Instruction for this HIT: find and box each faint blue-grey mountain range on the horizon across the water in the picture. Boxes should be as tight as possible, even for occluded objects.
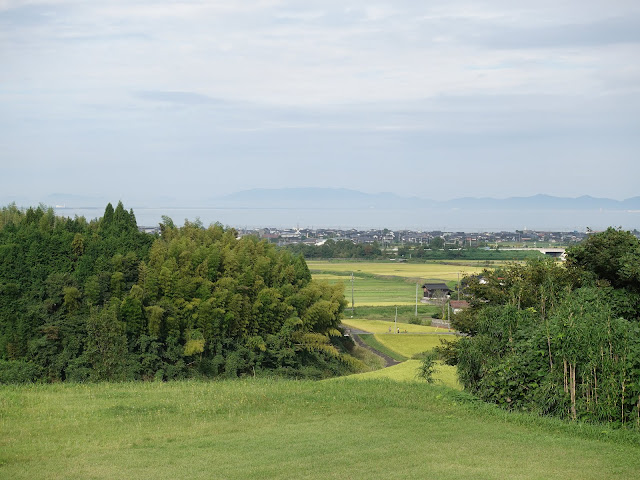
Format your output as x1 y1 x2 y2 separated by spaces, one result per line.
206 188 640 210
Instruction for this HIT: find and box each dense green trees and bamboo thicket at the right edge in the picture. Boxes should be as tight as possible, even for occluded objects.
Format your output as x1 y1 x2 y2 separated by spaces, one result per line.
450 228 640 426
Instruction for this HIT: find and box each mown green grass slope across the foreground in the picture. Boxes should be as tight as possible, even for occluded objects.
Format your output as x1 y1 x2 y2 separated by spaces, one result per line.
0 377 640 480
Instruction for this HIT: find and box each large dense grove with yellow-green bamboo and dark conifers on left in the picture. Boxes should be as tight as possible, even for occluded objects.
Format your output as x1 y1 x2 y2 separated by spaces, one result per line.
0 203 364 382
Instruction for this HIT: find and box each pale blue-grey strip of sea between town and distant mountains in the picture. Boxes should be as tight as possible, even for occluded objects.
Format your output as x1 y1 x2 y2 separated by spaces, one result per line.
55 206 640 232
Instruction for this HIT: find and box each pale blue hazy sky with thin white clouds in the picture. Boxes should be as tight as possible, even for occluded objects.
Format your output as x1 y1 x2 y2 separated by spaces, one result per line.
0 0 640 203
